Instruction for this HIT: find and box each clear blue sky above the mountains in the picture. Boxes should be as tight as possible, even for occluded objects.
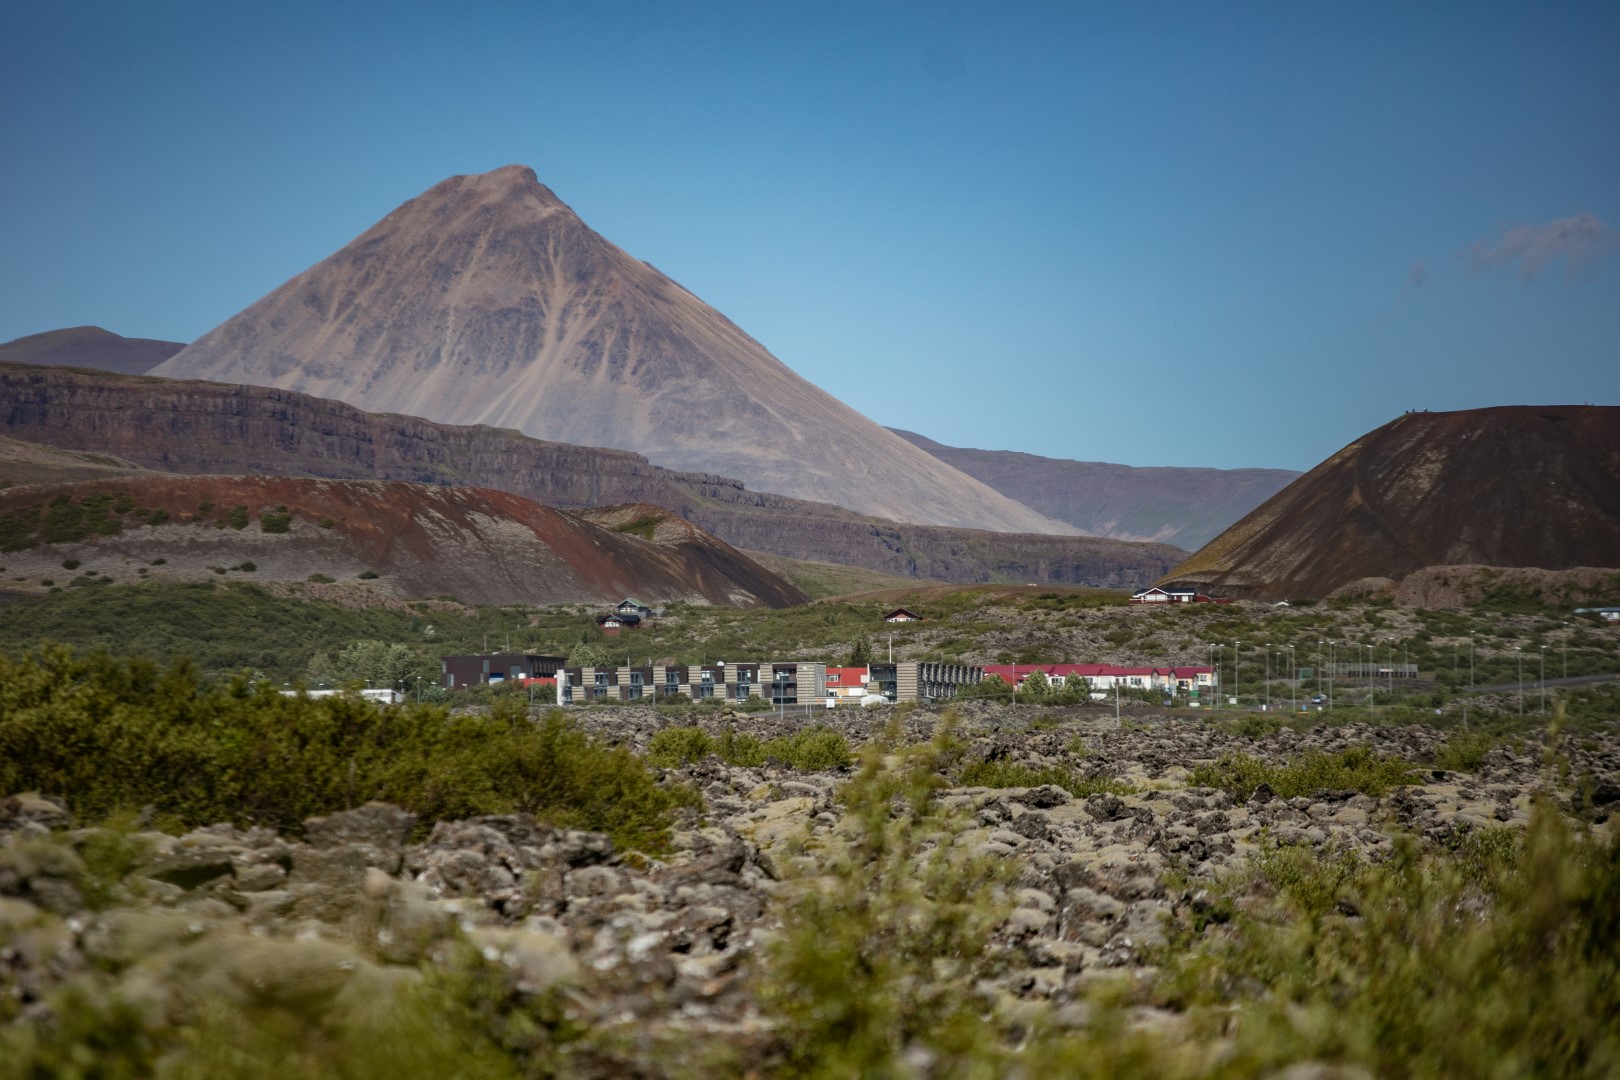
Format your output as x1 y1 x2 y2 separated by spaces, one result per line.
0 0 1620 468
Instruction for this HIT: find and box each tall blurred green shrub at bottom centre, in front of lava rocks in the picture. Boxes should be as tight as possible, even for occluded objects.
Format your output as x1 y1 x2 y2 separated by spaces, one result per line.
758 712 1014 1078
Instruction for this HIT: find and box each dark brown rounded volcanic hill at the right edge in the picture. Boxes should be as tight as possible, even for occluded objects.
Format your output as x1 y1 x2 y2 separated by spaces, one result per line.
1163 405 1620 599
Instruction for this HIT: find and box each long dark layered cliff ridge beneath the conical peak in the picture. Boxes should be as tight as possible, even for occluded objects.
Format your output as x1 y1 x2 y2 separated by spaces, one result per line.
0 364 1186 588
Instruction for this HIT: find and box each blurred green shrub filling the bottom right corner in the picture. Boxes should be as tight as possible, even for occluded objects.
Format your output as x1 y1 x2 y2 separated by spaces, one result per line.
1165 805 1620 1077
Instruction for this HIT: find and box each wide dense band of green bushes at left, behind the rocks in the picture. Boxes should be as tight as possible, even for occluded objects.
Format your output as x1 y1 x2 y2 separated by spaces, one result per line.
0 649 695 850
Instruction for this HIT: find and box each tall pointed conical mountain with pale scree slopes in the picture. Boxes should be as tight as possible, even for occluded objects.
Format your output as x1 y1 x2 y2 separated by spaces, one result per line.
145 165 1072 534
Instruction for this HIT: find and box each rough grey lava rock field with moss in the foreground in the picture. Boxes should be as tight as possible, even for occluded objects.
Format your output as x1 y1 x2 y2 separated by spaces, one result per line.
0 704 1620 1075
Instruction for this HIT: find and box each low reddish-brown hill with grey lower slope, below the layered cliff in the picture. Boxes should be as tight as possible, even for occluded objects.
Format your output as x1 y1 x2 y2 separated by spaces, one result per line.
0 476 807 607
